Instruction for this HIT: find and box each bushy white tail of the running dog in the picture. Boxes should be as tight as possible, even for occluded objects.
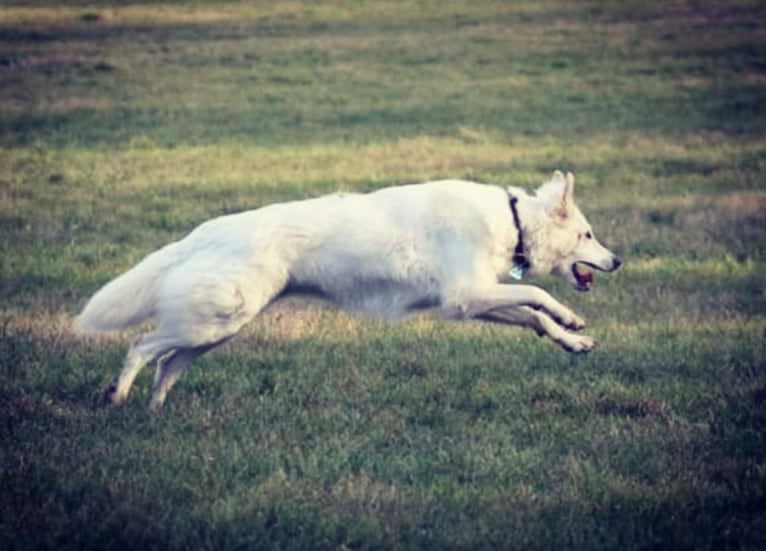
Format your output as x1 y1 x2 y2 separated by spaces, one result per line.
74 243 181 334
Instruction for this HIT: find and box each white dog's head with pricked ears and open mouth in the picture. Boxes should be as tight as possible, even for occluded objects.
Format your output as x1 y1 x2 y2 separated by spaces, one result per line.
530 171 622 291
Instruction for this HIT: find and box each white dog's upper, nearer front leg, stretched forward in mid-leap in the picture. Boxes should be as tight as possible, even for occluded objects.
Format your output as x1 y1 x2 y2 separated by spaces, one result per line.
448 284 585 331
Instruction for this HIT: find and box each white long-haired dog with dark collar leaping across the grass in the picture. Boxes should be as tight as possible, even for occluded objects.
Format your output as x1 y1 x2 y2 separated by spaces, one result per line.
76 172 621 409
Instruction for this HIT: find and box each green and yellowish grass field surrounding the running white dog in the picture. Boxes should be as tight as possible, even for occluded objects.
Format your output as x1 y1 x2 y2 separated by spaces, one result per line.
0 0 766 550
